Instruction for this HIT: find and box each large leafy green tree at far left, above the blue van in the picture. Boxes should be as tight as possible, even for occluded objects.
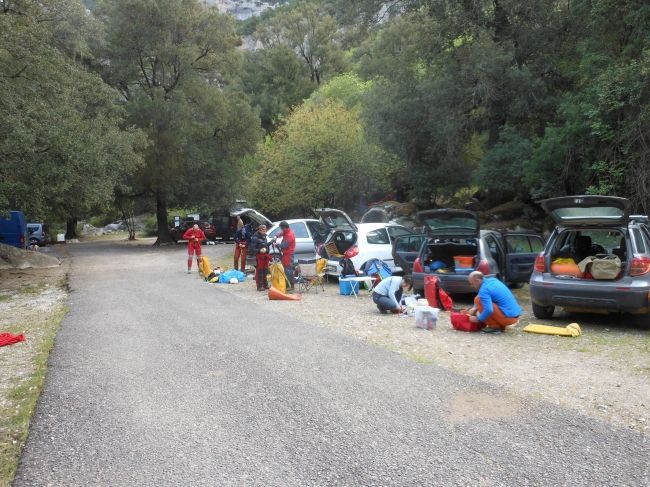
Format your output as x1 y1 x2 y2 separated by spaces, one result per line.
0 0 144 237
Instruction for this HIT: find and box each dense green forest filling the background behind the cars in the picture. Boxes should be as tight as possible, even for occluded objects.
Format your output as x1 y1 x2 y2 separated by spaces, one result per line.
0 0 650 240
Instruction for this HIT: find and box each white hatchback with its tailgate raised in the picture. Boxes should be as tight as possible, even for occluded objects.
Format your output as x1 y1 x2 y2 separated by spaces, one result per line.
314 208 413 277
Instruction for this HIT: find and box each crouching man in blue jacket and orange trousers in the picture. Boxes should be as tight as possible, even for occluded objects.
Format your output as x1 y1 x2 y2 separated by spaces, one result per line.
465 271 522 333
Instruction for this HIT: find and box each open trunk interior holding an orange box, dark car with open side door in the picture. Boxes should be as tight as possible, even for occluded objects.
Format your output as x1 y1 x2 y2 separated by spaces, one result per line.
423 239 480 275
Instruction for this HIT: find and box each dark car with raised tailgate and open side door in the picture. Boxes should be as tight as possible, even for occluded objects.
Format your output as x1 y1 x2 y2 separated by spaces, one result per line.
393 209 544 293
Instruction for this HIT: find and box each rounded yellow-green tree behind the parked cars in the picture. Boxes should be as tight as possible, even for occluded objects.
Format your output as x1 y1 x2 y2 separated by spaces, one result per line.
250 100 401 214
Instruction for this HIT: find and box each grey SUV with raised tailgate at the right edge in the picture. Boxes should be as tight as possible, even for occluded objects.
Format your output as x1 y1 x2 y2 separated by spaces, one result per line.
530 195 650 328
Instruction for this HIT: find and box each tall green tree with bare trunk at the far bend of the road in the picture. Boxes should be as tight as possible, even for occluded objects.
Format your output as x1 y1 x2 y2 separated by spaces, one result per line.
96 0 260 243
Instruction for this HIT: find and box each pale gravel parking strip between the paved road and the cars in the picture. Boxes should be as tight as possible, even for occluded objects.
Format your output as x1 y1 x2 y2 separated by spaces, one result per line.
210 262 650 431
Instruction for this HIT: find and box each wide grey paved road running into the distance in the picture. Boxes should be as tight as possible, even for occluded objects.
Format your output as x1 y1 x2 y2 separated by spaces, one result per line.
14 243 650 486
